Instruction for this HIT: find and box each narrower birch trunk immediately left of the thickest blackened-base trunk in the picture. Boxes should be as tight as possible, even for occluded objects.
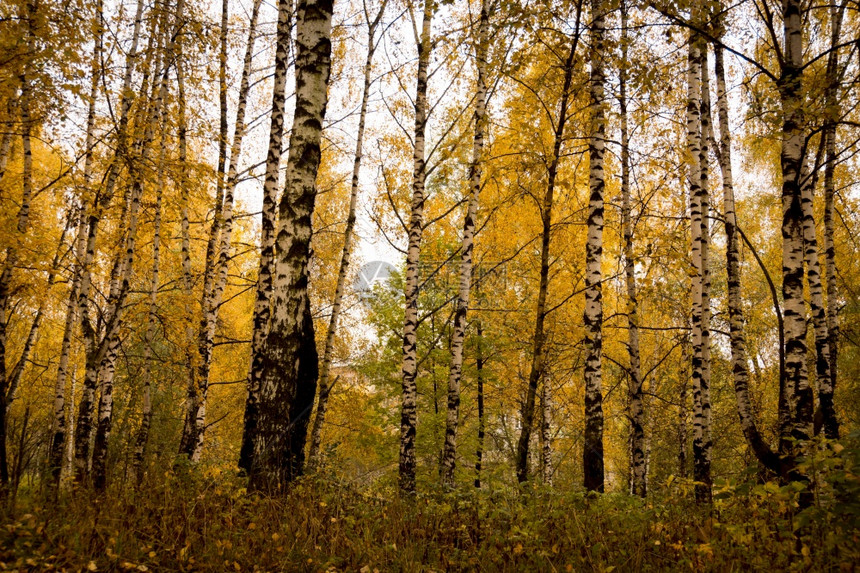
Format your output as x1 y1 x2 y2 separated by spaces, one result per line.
238 0 293 473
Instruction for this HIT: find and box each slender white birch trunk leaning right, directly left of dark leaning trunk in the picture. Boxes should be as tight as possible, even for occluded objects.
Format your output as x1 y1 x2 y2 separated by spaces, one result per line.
441 0 490 487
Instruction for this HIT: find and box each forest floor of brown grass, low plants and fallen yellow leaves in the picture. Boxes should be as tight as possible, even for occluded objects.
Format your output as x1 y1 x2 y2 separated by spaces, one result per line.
0 462 860 573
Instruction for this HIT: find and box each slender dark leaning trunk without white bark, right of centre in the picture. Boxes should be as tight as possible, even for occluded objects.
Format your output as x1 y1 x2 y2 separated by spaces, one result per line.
516 13 582 483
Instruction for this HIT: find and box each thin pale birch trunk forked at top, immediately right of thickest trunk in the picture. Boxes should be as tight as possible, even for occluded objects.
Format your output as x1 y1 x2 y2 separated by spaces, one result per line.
308 0 388 471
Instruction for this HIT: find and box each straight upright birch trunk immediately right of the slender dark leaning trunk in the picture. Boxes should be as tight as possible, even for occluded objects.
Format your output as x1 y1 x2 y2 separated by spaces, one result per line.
582 0 606 492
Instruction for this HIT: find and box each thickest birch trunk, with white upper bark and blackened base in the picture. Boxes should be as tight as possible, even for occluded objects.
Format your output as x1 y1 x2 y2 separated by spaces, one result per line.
250 0 332 492
